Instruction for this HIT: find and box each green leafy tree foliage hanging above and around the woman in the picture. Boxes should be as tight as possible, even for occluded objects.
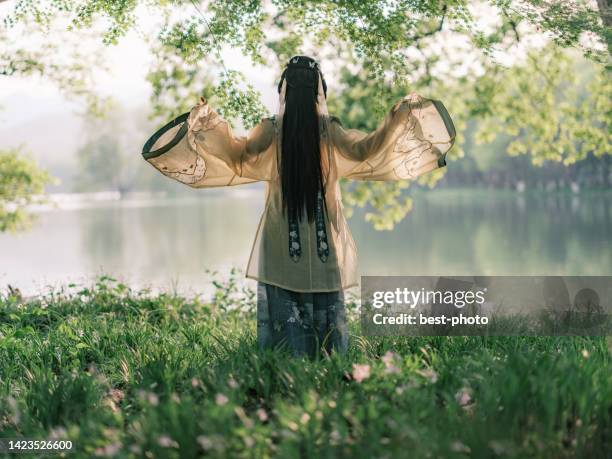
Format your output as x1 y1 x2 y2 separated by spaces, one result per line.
0 0 612 229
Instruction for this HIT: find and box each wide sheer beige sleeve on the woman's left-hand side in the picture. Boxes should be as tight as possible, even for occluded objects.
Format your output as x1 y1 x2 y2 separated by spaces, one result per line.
142 98 275 188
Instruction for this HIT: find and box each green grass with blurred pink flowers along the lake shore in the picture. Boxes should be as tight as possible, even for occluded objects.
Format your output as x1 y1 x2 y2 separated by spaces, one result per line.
0 278 612 458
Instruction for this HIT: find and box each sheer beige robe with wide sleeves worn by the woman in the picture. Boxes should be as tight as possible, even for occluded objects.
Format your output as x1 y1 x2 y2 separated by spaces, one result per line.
143 94 455 292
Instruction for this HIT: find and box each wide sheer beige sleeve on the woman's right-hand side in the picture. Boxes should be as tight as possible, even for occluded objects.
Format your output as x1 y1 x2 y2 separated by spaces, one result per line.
330 94 455 180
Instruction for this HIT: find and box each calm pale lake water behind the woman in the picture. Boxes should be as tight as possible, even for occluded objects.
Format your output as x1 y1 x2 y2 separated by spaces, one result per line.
0 189 612 294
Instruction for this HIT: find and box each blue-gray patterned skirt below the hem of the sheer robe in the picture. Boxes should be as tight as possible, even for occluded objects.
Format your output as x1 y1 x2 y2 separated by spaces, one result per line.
257 282 348 358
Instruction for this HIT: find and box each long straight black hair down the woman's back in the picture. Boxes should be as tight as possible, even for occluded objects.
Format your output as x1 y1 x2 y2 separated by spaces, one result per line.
278 56 327 221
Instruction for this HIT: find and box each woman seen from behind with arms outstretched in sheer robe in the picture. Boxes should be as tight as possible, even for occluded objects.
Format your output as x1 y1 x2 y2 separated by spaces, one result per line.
143 56 455 357
